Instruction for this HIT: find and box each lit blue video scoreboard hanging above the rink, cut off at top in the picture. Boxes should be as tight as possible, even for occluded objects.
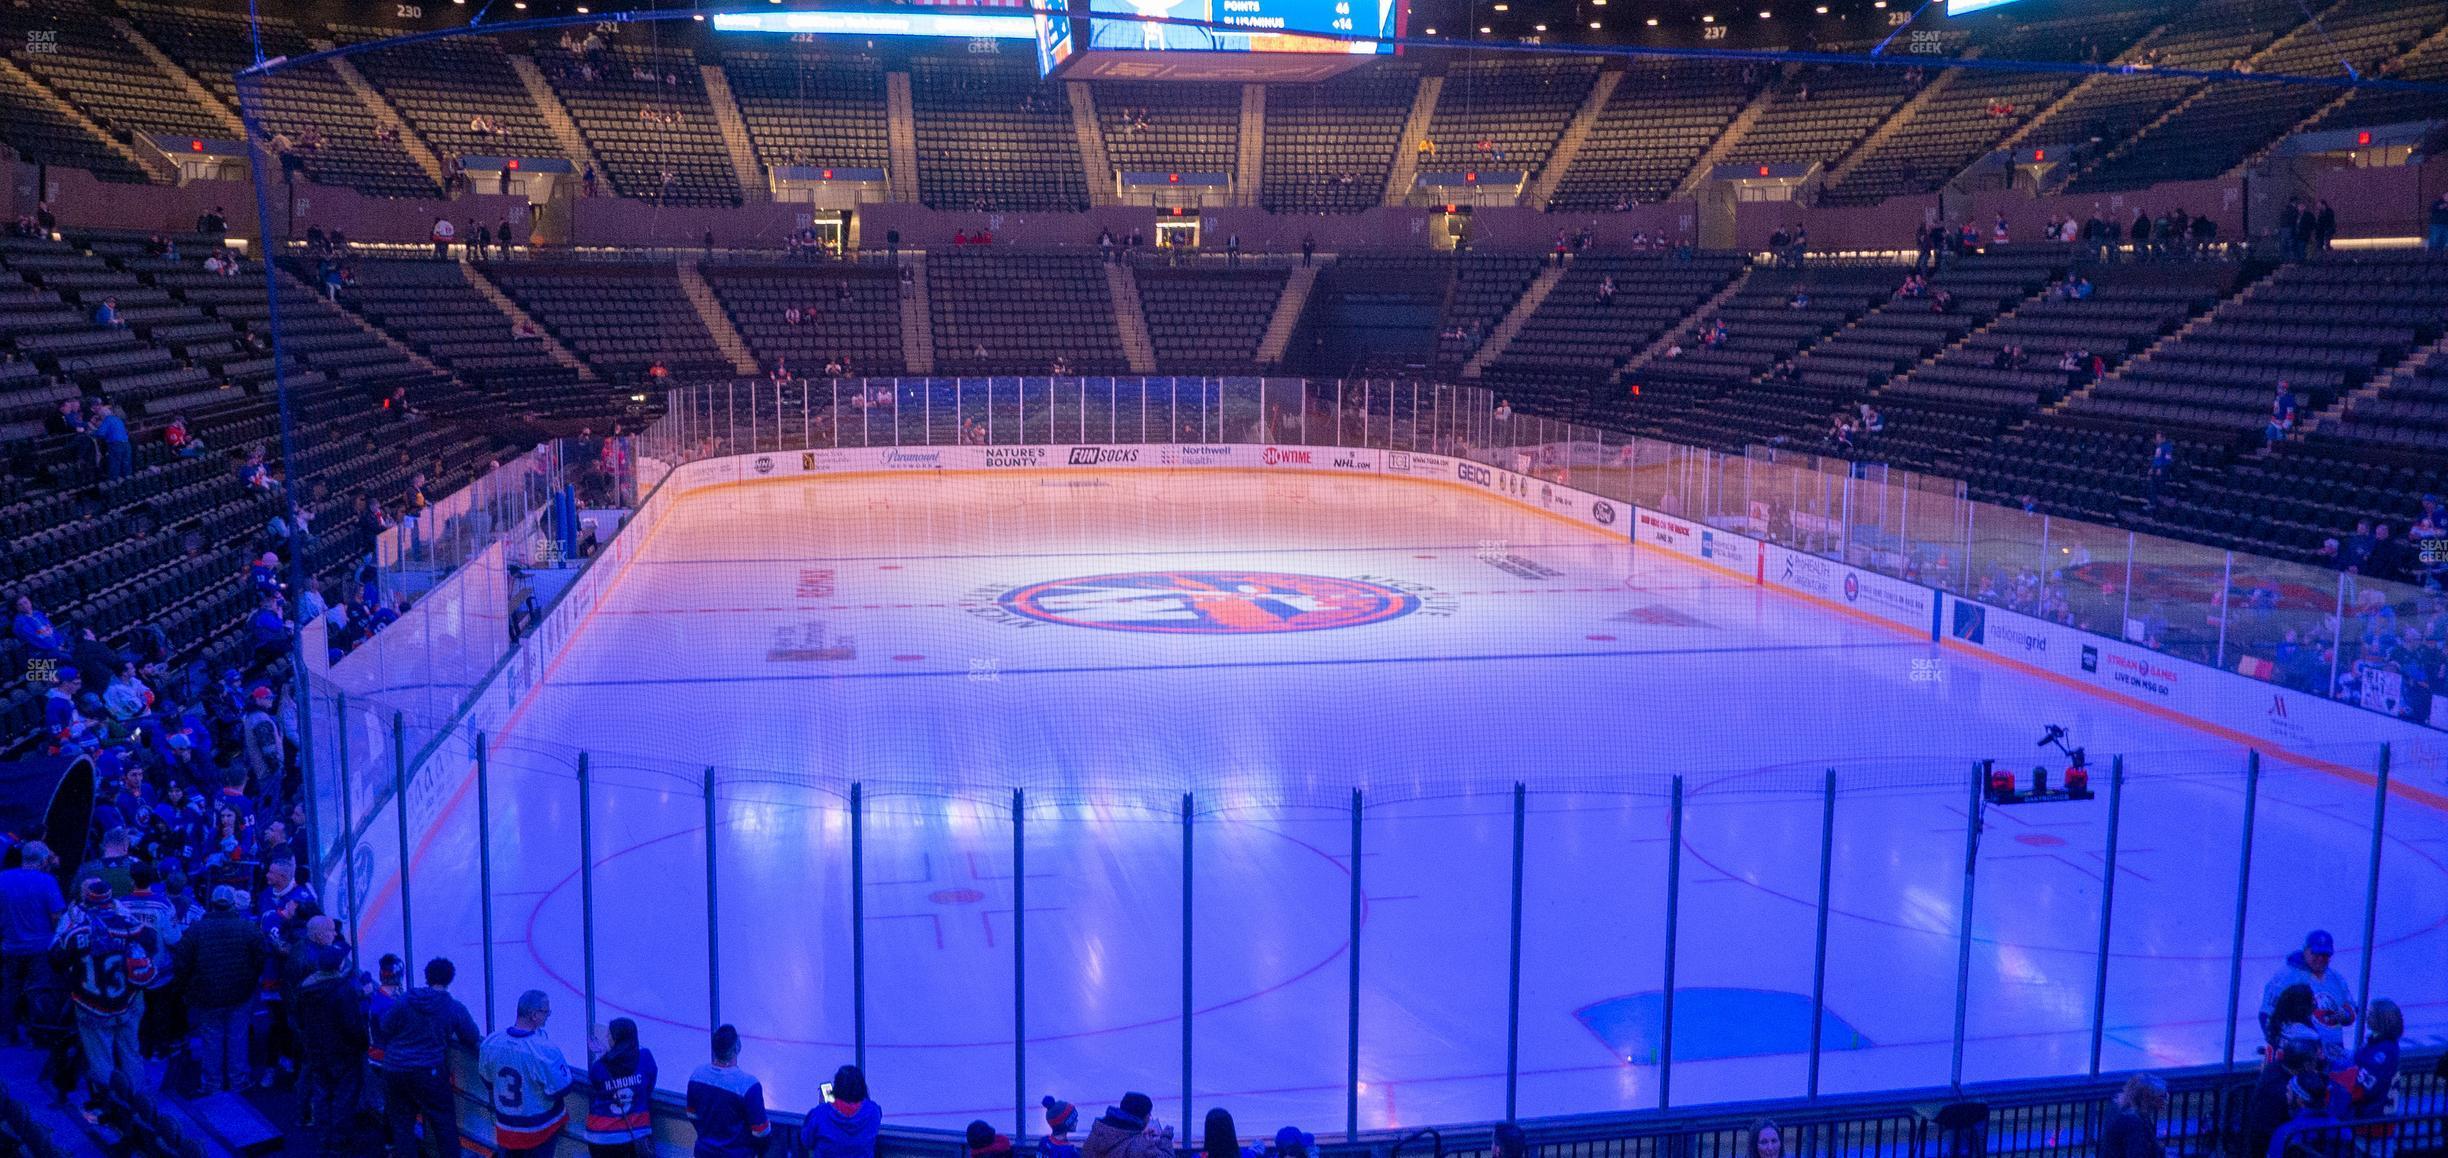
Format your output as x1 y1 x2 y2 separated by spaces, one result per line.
1036 0 1408 81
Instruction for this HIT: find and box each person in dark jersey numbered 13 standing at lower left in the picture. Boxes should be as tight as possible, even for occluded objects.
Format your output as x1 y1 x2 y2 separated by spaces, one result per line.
51 876 162 1106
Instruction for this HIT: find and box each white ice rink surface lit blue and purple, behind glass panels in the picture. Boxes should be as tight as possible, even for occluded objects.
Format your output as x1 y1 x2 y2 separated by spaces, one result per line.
372 473 2448 1134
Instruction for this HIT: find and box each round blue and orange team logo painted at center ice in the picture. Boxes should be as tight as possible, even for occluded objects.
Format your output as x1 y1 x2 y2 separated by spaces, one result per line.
996 570 1420 634
